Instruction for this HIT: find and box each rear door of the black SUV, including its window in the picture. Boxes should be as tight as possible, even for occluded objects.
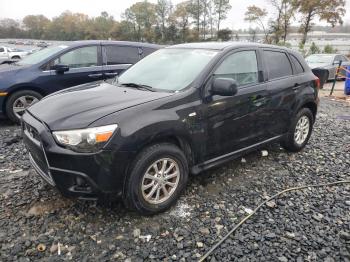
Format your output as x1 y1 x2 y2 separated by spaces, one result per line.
263 49 304 137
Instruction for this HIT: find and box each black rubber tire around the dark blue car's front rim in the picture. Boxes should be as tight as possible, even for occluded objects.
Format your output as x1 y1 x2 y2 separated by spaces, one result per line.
6 90 43 124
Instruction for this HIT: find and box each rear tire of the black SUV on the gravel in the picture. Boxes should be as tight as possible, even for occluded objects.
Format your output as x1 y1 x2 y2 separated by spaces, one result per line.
281 108 314 152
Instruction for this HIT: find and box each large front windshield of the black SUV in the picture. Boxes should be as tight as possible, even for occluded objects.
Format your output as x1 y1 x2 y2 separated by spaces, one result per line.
118 48 217 91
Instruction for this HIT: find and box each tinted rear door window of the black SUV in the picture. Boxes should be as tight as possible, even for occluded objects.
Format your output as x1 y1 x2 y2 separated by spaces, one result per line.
264 51 293 80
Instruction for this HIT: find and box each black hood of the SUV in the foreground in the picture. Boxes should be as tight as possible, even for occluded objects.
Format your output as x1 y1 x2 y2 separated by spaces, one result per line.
27 82 173 131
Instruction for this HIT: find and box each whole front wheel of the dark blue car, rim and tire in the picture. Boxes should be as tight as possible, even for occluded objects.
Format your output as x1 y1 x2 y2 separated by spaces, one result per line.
6 90 42 123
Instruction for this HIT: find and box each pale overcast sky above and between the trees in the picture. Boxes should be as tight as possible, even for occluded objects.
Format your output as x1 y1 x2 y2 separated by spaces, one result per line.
0 0 350 29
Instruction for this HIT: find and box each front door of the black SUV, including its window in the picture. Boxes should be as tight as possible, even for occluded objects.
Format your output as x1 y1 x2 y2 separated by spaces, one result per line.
204 49 268 160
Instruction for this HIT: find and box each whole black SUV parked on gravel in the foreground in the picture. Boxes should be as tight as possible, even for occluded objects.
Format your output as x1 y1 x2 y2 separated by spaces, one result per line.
23 43 319 214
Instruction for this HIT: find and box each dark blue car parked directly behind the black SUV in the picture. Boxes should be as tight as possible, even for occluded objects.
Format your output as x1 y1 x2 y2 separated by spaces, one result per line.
0 41 161 122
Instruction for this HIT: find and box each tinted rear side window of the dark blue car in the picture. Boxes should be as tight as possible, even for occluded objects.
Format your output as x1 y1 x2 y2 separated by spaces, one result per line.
105 45 139 65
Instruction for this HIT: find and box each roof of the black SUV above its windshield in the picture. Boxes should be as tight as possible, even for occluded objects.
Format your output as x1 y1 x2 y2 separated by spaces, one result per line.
167 42 289 50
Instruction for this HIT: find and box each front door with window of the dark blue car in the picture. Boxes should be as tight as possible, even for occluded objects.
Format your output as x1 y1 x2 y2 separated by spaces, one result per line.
43 45 103 92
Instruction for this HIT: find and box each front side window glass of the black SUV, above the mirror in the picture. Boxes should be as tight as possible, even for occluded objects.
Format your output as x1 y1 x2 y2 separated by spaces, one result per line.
214 51 258 86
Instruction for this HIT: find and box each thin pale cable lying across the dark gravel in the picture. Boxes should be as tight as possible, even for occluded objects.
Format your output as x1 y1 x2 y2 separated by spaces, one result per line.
199 180 350 262
